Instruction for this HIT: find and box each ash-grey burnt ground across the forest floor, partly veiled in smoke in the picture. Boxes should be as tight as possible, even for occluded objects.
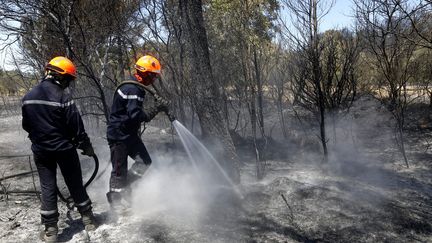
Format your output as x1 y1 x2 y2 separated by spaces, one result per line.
0 97 432 242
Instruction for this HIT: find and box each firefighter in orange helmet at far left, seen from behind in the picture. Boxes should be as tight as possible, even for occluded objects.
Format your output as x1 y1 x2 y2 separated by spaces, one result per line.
22 56 96 242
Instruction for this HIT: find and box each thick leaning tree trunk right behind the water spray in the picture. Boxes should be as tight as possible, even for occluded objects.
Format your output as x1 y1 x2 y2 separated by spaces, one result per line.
179 0 240 182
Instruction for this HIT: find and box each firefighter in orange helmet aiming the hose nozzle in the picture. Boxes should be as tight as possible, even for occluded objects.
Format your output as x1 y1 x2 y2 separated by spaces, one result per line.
107 55 168 209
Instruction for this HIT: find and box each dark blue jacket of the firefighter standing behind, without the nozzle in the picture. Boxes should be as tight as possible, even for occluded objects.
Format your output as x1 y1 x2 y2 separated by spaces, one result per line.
22 79 90 152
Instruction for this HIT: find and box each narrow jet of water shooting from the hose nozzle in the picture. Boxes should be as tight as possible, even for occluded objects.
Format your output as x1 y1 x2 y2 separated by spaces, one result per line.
173 120 243 198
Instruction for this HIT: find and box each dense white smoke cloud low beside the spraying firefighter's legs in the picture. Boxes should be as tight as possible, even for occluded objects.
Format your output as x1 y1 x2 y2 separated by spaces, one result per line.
133 155 210 221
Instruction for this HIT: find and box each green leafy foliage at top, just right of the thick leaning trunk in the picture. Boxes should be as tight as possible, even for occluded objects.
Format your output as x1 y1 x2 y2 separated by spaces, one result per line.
205 0 279 89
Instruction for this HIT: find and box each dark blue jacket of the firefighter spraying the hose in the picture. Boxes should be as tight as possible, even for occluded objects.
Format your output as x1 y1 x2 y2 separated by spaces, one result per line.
107 80 150 142
